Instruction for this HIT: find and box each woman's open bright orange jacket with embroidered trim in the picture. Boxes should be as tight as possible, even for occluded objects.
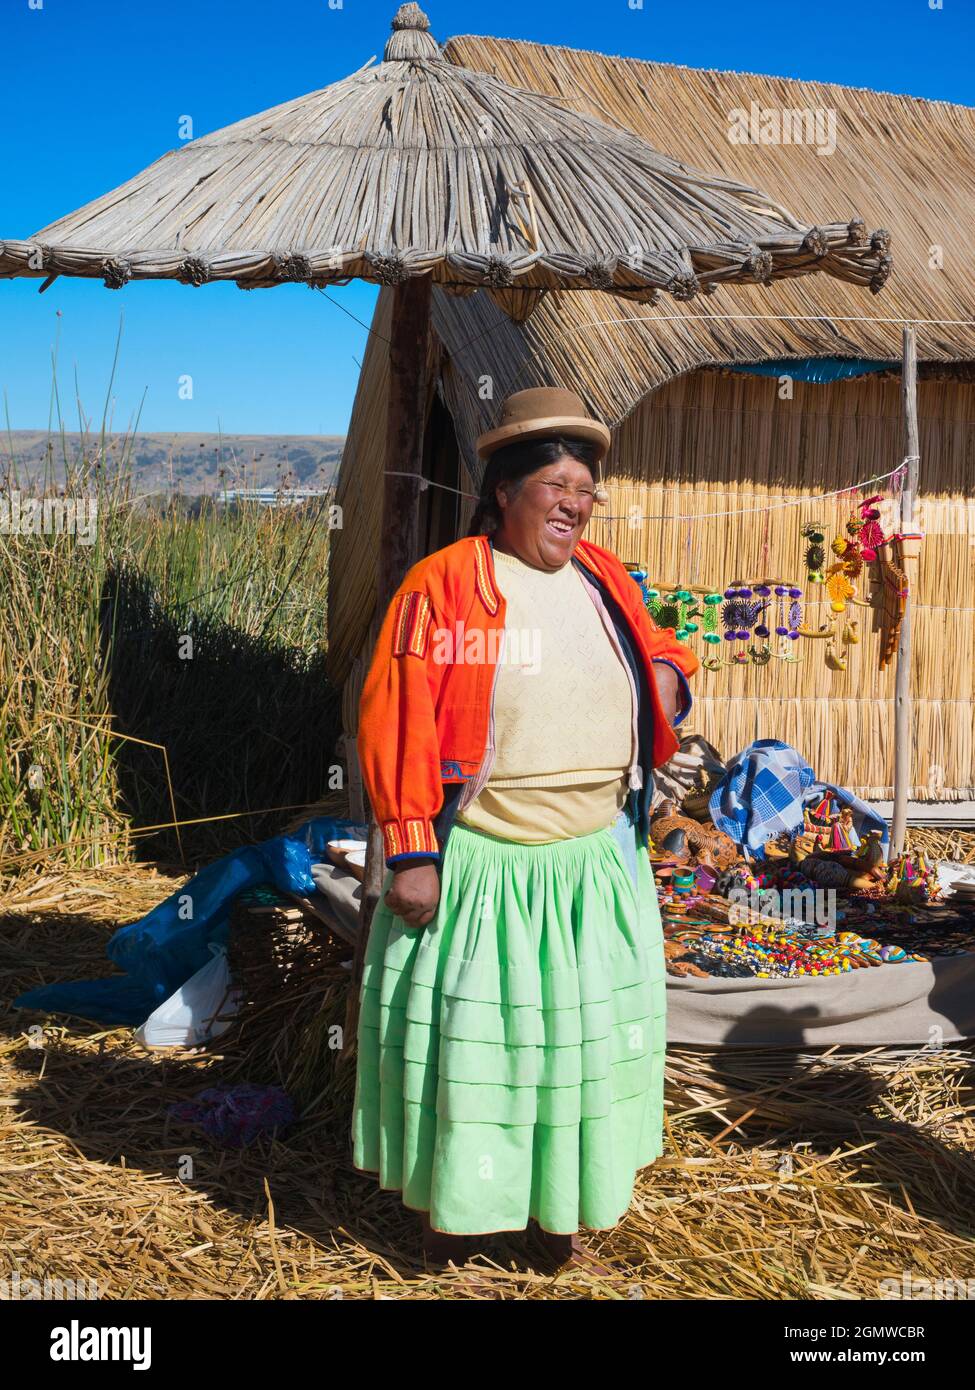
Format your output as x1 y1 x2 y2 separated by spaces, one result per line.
359 535 700 865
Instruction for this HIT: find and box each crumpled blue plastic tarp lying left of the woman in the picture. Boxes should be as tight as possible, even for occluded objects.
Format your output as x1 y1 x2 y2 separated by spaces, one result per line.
14 816 366 1027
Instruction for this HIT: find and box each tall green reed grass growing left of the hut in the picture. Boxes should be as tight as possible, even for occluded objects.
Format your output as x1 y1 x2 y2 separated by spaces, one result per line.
0 369 338 877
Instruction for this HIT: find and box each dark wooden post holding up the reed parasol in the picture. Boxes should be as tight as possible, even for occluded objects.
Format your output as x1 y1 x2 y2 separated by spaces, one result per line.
342 275 433 1058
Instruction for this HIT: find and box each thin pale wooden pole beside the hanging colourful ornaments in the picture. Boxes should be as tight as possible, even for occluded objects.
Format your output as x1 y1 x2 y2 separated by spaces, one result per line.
890 328 919 859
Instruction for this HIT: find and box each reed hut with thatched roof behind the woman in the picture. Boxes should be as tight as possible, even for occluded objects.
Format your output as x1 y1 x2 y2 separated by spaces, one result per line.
330 36 975 817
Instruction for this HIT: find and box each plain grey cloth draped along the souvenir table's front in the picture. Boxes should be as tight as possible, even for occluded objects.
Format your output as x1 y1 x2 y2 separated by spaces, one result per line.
668 955 975 1047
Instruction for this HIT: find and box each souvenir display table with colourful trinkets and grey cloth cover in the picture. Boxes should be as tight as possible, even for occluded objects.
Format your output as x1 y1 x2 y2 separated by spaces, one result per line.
655 856 975 1049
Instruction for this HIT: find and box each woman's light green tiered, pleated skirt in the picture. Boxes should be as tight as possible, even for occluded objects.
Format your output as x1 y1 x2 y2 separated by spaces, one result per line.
352 817 666 1234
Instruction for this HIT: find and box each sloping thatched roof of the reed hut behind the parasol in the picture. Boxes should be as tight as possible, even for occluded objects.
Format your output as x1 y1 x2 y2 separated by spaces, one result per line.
434 36 975 442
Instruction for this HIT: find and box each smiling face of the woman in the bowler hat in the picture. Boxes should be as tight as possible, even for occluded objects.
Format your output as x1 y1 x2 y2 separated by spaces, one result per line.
494 453 595 570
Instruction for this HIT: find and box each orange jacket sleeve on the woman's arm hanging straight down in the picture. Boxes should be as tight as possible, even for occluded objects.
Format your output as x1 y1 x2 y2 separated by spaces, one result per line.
357 574 445 866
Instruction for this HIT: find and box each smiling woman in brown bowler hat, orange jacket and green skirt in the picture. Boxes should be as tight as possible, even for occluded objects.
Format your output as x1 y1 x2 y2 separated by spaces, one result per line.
353 388 698 1262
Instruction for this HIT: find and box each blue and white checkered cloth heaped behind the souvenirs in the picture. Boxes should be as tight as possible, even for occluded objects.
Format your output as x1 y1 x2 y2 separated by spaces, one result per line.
708 738 889 859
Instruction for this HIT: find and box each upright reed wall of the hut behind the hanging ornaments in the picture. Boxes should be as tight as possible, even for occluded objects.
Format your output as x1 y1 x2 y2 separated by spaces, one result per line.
330 363 975 801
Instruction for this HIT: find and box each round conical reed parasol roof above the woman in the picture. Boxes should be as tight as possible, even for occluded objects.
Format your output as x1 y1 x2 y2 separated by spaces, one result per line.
0 4 890 318
